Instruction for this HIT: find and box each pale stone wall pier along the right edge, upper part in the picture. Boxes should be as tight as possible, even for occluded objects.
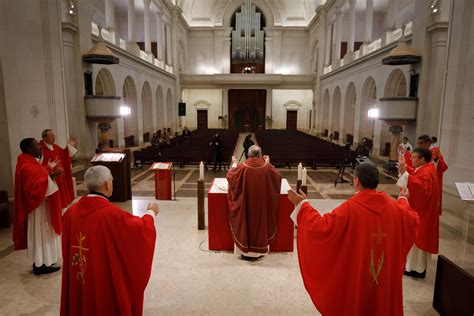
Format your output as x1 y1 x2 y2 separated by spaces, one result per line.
438 0 474 210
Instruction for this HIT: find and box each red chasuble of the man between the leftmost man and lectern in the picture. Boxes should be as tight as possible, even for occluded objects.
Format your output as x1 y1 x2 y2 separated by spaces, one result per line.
39 140 74 208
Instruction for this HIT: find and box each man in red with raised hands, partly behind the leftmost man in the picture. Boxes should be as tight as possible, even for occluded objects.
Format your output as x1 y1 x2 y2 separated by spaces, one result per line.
40 129 77 208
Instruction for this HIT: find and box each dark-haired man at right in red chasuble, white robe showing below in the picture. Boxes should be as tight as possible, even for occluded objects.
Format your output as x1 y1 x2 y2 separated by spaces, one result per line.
397 148 441 278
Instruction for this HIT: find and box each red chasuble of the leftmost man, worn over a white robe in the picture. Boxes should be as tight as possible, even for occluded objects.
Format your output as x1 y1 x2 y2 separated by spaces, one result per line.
13 154 61 250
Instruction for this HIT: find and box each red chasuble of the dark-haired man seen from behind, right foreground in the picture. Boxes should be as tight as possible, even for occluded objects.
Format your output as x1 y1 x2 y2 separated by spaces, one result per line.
297 190 418 316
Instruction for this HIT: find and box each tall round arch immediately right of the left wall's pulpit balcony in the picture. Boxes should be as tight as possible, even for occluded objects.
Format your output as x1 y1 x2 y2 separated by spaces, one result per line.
122 76 138 144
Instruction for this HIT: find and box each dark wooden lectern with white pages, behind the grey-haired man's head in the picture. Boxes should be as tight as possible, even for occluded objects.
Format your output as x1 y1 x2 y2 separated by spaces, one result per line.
91 148 132 202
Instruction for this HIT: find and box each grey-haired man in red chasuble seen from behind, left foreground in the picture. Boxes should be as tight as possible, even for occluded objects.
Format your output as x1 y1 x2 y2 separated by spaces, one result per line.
61 166 159 315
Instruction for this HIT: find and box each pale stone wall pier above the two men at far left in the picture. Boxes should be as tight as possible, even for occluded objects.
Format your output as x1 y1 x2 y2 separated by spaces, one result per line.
0 1 68 190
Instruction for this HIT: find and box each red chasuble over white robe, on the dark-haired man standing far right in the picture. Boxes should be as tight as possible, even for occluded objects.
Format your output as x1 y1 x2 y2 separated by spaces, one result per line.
407 163 441 253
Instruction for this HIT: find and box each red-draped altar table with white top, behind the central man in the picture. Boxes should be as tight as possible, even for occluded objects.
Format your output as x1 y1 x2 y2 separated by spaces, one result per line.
208 178 294 252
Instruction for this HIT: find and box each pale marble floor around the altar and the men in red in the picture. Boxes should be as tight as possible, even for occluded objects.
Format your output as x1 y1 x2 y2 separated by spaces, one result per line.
0 193 474 315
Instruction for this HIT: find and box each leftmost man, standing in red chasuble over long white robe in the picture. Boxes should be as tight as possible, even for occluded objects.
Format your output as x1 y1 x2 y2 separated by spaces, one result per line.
13 138 61 275
